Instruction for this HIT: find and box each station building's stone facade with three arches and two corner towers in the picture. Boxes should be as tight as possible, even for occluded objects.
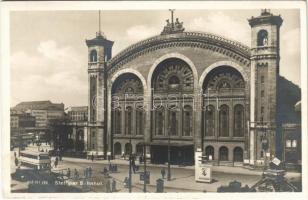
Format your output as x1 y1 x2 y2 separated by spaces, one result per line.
87 10 282 165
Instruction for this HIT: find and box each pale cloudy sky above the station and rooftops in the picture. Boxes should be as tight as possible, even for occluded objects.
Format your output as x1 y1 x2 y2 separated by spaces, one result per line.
10 9 300 107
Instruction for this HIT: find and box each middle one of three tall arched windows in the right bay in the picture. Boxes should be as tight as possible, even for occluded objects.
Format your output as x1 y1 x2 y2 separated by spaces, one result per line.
219 105 229 137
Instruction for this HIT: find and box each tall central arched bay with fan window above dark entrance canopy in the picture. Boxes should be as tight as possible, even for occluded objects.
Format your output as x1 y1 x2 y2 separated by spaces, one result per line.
151 57 197 165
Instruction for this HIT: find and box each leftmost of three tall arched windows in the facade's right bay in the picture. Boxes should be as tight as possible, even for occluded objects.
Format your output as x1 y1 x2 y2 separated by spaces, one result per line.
203 105 215 136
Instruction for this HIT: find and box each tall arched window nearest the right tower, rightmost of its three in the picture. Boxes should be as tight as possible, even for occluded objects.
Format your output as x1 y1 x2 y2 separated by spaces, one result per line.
234 105 244 137
